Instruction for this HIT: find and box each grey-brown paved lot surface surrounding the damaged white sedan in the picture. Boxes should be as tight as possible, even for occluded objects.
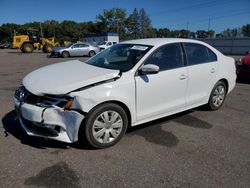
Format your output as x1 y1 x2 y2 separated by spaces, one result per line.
0 50 250 188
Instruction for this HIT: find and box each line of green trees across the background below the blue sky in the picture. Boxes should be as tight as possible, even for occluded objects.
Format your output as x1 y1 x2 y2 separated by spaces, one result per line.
0 8 250 42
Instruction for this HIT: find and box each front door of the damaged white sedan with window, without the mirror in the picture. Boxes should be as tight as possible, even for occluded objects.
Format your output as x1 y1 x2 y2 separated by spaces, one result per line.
135 43 187 121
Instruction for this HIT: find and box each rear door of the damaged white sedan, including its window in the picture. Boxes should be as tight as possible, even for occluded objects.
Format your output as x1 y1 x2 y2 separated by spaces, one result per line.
184 43 218 107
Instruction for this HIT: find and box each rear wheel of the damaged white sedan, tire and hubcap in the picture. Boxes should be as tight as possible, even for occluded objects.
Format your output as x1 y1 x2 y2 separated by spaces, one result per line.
207 81 227 110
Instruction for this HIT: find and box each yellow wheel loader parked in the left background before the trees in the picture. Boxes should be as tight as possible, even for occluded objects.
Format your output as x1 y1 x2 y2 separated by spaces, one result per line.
12 29 59 53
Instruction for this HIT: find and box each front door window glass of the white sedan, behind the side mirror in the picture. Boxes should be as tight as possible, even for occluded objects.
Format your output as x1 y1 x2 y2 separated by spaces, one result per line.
144 43 183 71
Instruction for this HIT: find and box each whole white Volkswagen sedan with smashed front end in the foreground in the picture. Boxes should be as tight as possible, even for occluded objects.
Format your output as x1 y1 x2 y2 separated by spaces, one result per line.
14 38 236 148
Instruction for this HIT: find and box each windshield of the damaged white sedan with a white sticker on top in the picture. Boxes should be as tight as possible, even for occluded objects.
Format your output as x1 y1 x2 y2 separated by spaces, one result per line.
87 44 152 72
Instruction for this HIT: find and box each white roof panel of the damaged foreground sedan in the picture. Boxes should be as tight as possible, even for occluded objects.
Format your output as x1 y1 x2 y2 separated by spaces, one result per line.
122 38 206 46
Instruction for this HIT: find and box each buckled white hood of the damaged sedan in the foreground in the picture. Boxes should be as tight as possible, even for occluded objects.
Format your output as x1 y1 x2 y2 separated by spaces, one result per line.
23 60 119 96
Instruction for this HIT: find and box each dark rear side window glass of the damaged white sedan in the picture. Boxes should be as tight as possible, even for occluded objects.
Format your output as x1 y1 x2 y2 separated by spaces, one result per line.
184 43 217 65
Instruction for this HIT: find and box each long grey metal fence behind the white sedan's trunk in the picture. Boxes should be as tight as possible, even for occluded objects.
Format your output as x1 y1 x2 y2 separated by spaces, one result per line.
199 38 250 55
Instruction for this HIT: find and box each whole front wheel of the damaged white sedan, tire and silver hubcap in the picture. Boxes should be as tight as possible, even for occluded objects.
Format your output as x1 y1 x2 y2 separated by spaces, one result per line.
83 103 128 148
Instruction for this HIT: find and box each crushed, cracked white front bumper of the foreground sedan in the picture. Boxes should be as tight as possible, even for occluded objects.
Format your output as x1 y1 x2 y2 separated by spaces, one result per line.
14 97 84 143
